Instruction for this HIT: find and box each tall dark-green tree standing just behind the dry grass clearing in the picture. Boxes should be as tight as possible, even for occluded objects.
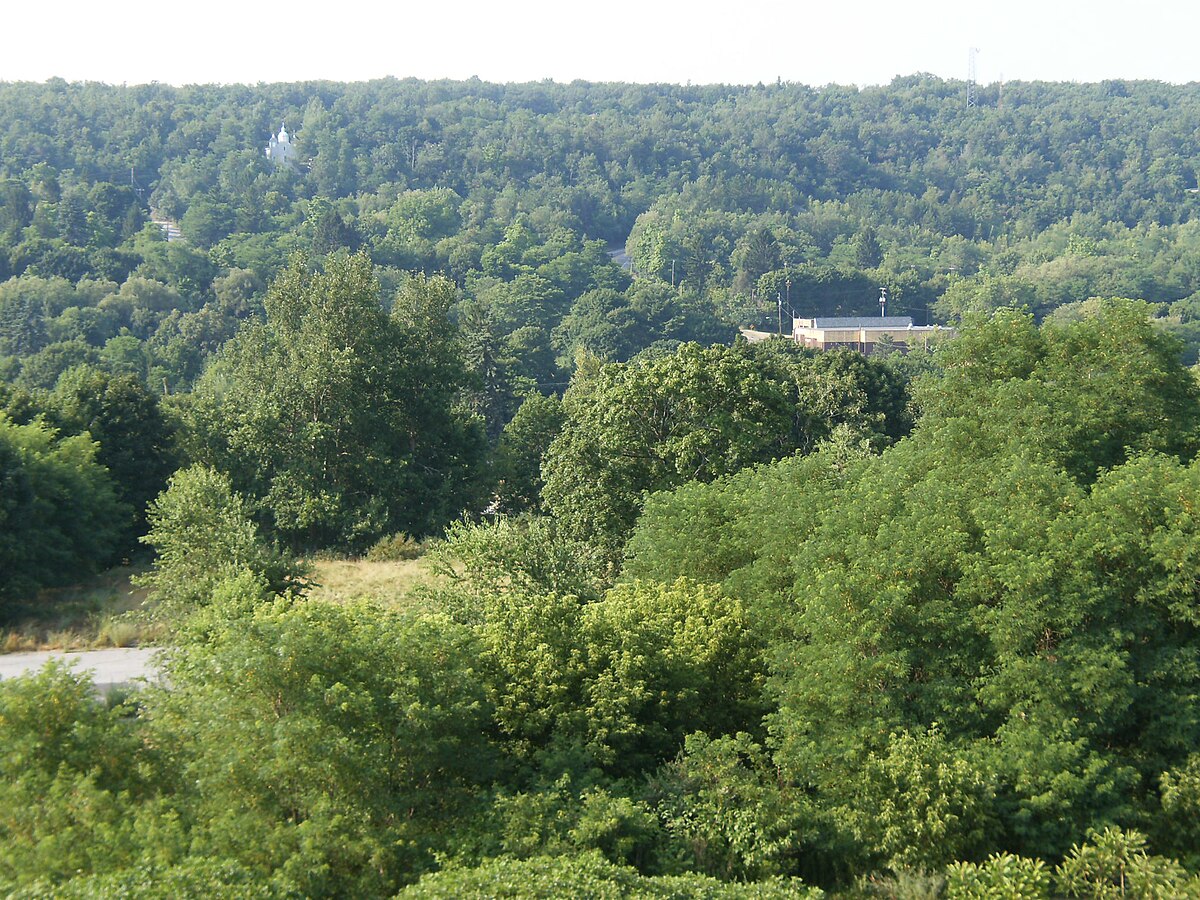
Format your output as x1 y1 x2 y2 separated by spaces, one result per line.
192 254 484 550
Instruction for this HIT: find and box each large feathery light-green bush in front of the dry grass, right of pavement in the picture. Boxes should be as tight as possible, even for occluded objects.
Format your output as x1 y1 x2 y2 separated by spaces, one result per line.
154 600 496 896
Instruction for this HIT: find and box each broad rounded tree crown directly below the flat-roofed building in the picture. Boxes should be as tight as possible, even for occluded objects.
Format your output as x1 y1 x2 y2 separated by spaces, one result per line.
542 342 907 552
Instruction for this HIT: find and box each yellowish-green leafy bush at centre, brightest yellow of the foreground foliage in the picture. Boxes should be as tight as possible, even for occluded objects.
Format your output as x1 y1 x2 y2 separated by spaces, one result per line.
479 578 766 778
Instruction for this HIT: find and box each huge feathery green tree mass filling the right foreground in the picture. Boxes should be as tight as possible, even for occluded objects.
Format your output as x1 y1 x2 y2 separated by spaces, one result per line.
768 304 1200 857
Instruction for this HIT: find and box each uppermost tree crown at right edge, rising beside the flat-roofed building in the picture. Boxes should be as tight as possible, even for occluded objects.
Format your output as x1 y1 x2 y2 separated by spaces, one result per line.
917 300 1200 481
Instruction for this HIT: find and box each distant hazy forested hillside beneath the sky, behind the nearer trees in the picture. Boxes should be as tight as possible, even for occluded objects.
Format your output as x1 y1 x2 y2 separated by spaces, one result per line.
0 77 1200 390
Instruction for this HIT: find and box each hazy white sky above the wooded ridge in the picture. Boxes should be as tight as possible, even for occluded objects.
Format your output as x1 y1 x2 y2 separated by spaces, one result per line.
9 0 1200 85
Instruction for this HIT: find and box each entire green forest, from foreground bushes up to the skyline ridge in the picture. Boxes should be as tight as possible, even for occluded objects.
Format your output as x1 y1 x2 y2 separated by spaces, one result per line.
7 76 1200 898
